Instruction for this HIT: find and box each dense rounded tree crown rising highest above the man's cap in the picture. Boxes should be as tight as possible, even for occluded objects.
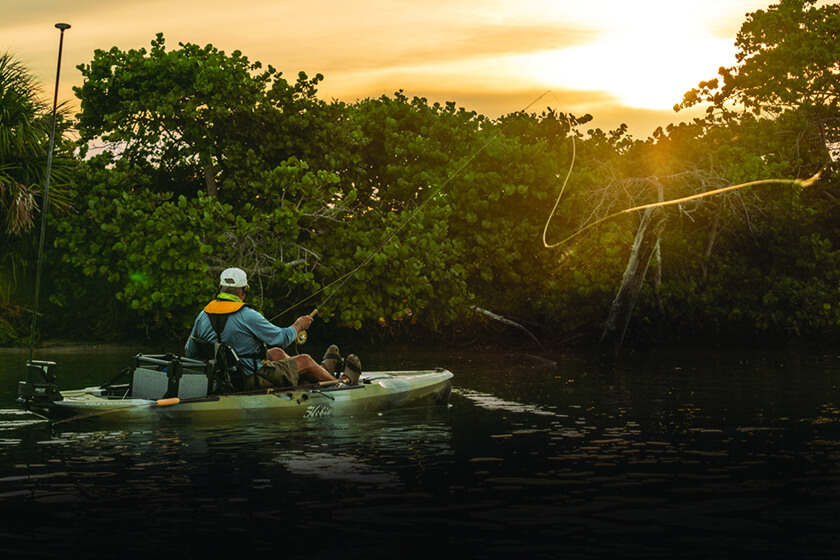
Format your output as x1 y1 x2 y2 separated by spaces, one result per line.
75 33 340 202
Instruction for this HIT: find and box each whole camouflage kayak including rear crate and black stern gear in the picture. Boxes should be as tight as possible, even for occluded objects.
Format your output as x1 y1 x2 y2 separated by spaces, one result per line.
18 356 453 423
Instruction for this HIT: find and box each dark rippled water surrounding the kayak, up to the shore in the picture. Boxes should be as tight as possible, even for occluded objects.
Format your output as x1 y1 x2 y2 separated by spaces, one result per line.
0 344 840 558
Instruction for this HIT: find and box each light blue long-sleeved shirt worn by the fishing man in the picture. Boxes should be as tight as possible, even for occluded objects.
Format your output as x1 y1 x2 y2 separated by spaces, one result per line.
184 294 297 375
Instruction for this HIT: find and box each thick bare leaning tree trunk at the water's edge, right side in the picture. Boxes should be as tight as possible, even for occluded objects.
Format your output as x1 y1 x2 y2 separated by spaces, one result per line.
601 208 665 355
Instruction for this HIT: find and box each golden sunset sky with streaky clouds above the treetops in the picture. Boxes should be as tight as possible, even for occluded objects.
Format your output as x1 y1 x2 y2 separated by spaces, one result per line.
0 0 808 138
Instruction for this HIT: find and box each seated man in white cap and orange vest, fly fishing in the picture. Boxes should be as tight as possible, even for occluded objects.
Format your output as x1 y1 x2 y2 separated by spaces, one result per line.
185 268 361 390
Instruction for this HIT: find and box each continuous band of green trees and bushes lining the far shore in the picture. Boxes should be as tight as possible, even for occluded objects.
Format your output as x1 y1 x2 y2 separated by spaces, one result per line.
0 0 840 351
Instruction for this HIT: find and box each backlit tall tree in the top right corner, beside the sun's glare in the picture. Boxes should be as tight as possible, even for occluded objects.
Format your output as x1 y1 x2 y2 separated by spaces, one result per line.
674 0 840 174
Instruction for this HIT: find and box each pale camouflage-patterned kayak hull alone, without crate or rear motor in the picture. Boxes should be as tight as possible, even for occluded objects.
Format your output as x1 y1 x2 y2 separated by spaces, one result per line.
41 369 453 422
